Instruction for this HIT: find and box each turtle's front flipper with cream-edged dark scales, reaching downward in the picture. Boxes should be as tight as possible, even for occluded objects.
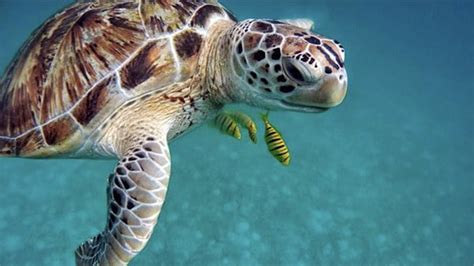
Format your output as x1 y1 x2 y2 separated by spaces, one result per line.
76 137 171 265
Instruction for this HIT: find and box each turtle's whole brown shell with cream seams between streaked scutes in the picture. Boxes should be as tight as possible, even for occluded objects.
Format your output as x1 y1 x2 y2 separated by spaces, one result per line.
0 0 235 157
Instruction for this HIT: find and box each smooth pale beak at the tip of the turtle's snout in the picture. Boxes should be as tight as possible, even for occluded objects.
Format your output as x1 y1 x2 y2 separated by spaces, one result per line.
288 68 347 108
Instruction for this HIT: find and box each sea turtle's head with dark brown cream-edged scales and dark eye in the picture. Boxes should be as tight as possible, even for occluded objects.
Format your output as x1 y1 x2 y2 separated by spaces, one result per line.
231 20 347 112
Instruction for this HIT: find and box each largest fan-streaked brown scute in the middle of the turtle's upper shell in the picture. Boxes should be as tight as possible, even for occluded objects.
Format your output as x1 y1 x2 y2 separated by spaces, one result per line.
40 3 145 123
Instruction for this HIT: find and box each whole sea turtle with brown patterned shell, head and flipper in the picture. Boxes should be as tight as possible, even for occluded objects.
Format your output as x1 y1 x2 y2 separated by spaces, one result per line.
0 0 347 265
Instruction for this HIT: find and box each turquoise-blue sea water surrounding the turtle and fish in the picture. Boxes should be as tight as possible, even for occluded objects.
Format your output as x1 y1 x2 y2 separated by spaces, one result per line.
0 0 474 265
